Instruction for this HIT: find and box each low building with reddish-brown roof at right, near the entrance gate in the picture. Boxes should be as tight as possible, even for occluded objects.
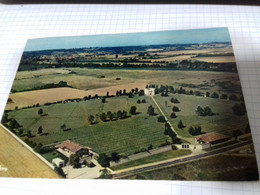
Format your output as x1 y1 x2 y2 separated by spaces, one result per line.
195 132 229 146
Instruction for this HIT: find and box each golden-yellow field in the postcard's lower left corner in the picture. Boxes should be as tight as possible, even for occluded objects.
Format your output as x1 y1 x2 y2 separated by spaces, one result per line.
0 126 59 178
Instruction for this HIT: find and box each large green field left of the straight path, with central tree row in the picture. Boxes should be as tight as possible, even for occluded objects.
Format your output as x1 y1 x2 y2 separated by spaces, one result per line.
8 96 169 154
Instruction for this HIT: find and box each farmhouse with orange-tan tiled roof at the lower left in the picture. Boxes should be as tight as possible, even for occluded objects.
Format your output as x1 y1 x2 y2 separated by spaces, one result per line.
55 140 90 158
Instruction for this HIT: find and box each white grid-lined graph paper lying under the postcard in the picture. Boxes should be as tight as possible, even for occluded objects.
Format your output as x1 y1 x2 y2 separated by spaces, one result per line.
0 4 260 195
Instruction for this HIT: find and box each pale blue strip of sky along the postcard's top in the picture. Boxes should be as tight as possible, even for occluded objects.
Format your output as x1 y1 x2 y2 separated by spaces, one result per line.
25 28 231 51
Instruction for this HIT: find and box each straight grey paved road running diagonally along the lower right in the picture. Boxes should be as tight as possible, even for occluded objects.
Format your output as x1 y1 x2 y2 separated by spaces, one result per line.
113 140 252 179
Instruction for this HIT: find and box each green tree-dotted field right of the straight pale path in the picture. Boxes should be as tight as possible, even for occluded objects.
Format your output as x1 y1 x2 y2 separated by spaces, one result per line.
155 94 248 137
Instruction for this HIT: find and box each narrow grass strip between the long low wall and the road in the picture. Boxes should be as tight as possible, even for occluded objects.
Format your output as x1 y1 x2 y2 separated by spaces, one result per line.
111 149 191 171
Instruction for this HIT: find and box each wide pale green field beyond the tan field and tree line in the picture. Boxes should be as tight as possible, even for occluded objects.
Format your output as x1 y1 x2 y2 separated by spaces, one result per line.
12 68 240 91
